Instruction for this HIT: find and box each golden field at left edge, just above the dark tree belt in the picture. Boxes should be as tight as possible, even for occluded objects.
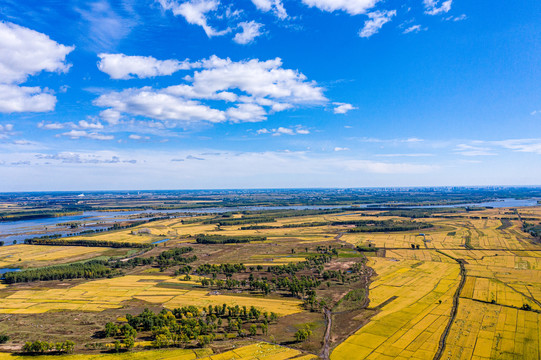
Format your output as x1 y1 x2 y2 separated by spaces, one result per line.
0 244 118 268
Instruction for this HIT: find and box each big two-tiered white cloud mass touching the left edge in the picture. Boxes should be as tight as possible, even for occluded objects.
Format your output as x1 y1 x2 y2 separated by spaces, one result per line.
0 22 74 113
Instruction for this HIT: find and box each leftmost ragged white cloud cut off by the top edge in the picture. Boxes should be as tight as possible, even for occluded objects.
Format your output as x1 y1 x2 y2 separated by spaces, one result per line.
158 0 230 37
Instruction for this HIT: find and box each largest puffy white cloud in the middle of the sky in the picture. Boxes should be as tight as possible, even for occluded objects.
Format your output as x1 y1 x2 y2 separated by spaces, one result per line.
94 56 327 124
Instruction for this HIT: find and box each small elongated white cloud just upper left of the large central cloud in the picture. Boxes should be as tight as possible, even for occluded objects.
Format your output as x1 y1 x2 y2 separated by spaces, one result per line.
98 54 192 80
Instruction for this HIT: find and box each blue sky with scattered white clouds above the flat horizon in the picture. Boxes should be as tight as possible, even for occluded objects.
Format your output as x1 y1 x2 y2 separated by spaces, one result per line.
0 0 541 191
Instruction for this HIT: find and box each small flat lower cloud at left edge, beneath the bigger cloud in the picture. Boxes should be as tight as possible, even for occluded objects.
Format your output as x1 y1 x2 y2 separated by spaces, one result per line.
0 84 56 113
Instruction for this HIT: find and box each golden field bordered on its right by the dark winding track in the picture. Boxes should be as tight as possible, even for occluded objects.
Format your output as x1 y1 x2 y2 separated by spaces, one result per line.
331 258 459 360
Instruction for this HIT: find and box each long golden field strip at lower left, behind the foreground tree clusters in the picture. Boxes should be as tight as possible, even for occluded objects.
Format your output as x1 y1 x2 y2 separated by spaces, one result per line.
0 275 302 315
